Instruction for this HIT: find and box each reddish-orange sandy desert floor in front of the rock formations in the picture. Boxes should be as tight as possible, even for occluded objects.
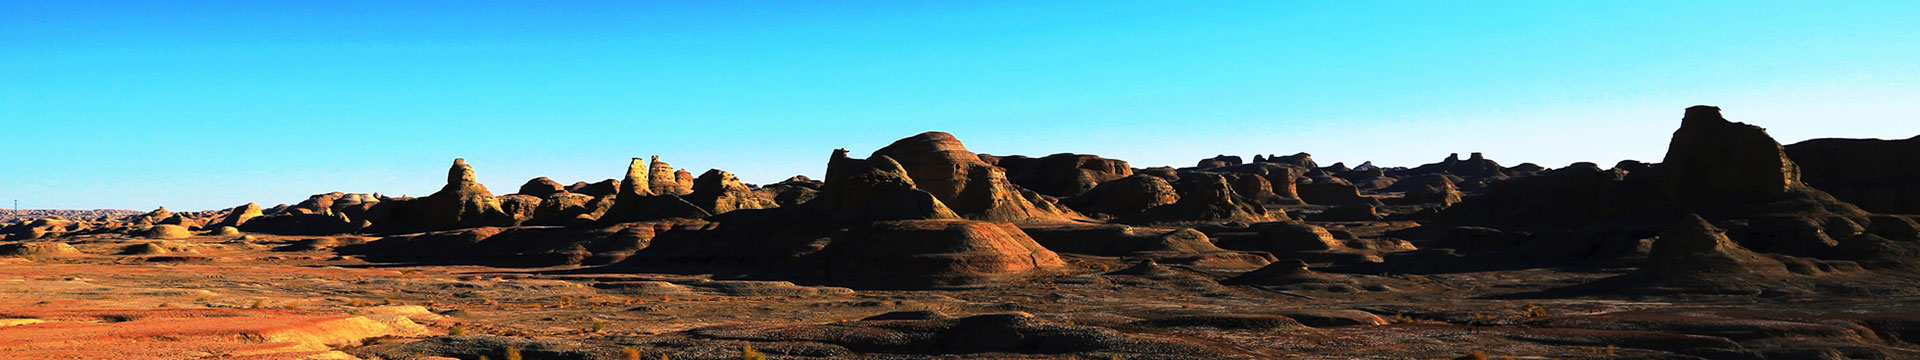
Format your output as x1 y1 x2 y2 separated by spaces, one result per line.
0 230 1920 360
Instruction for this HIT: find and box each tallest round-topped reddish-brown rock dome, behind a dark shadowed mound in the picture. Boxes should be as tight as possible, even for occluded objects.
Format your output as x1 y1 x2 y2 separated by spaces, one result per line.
870 132 1079 222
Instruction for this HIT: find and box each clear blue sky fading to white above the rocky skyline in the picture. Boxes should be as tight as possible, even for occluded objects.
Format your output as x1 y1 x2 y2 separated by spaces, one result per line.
0 0 1920 211
